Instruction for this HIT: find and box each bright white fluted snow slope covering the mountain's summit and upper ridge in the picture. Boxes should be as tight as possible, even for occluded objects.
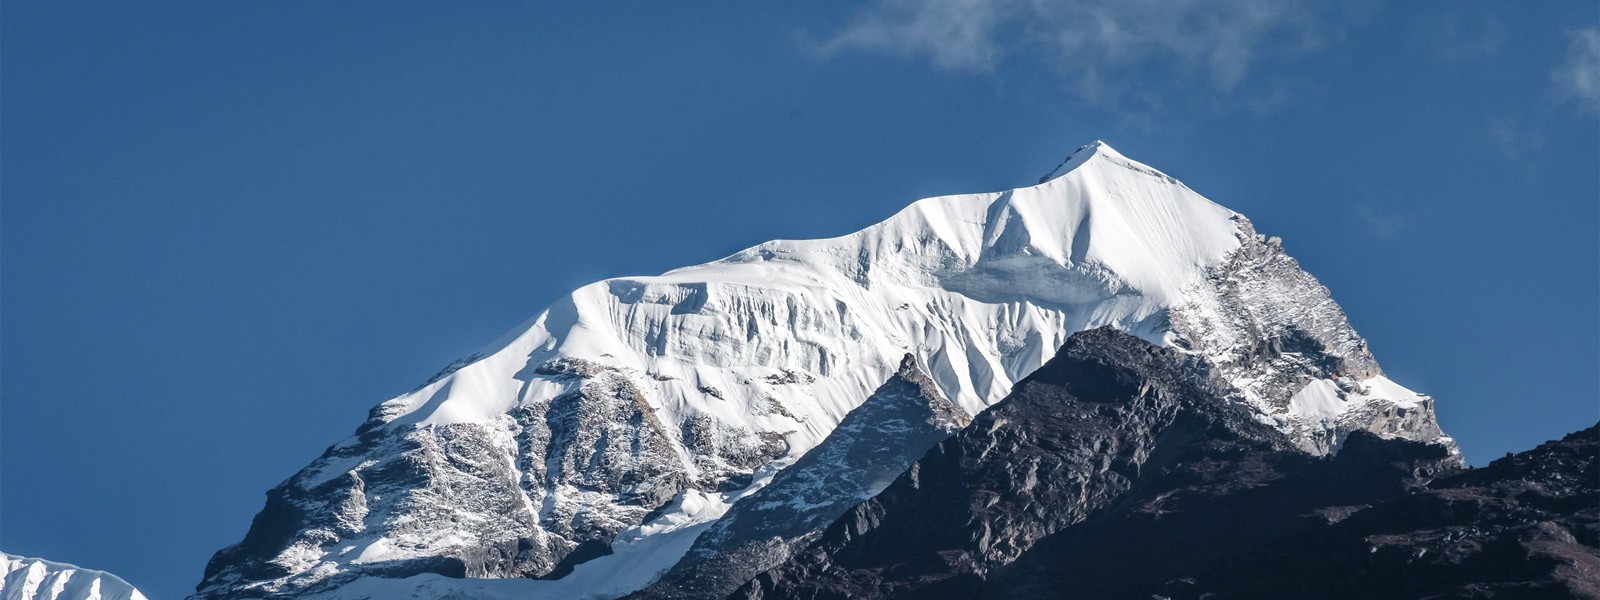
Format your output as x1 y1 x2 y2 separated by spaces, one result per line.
400 144 1240 441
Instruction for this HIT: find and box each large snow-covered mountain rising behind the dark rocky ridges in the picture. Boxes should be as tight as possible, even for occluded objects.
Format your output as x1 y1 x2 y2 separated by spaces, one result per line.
197 142 1453 598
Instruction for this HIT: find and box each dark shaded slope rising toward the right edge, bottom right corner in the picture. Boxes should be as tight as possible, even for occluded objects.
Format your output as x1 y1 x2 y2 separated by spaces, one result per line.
1168 426 1600 598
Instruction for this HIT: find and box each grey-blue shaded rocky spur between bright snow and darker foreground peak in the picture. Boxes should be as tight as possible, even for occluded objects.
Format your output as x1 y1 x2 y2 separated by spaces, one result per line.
630 355 970 598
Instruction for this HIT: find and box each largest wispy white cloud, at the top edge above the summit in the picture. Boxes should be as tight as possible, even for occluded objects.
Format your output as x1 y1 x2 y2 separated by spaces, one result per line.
814 0 1328 102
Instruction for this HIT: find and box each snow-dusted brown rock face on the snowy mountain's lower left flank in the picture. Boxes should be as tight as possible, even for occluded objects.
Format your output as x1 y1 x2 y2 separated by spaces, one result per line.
198 360 720 597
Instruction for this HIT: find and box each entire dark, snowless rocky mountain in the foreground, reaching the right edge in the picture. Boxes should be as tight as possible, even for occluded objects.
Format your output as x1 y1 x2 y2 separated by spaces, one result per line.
734 328 1600 598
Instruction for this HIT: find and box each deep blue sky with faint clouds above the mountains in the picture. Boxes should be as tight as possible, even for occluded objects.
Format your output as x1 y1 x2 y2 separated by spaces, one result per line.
0 0 1600 598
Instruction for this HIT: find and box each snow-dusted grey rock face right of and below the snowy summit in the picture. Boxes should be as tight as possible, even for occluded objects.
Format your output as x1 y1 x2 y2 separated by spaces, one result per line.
1170 218 1448 454
